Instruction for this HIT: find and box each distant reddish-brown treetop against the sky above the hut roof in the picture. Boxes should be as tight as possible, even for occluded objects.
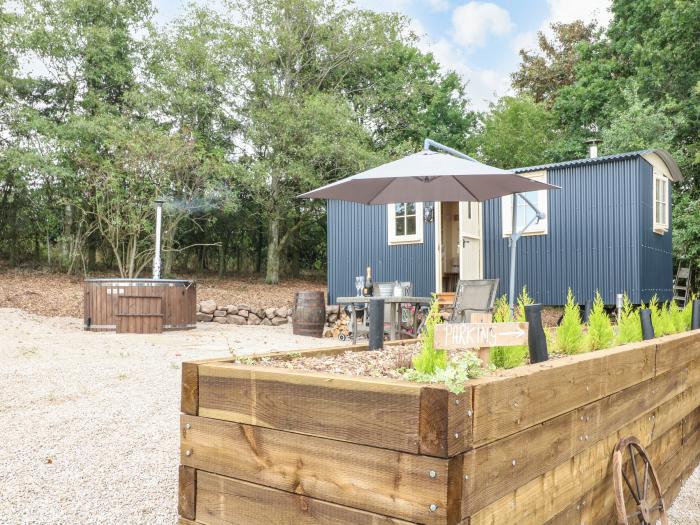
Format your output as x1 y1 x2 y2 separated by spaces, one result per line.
511 20 601 107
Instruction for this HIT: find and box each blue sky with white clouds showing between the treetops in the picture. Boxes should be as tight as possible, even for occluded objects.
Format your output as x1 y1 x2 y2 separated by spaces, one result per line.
154 0 611 110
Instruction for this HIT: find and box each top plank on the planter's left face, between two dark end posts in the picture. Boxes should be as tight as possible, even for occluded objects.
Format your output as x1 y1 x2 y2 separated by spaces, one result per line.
199 364 424 454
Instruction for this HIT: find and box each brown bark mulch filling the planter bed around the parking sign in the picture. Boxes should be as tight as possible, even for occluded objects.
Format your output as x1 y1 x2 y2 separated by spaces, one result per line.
238 343 486 379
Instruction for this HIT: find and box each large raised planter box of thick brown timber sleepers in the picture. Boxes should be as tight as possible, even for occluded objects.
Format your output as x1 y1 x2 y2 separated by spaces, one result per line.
179 331 700 525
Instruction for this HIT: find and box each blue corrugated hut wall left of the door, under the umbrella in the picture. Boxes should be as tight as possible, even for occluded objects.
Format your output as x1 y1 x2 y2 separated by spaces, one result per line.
328 201 435 304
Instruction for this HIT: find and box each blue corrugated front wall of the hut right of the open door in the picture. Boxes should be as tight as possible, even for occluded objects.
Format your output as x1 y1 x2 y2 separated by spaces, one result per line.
484 157 653 304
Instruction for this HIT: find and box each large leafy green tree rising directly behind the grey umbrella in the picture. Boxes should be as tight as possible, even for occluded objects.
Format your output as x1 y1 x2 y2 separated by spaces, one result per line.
229 0 468 283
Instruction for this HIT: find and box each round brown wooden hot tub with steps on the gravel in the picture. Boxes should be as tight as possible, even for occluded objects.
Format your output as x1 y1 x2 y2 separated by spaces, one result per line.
83 278 197 334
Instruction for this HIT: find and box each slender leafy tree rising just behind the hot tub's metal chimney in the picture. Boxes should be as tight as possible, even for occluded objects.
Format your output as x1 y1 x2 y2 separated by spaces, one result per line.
139 7 240 275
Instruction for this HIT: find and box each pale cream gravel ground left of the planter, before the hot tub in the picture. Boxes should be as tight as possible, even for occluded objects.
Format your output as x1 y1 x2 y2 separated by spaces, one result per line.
0 308 348 525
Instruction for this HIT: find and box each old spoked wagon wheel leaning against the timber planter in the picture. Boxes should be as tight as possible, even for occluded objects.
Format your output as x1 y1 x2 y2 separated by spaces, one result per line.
613 436 668 525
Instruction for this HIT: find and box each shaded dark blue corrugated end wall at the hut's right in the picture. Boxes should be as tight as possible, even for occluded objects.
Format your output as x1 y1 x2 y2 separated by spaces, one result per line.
640 160 673 302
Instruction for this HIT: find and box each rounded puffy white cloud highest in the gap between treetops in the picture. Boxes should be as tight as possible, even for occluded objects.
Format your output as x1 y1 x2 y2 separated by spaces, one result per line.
452 2 513 47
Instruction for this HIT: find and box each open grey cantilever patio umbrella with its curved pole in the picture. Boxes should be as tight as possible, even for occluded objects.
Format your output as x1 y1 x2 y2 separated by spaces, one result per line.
300 139 558 308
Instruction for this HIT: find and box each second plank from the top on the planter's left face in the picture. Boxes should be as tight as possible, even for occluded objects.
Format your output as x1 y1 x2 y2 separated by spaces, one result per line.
180 415 452 524
